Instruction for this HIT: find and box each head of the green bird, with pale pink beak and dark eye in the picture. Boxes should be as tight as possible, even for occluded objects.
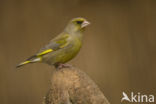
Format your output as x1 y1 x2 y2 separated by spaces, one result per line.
66 17 90 32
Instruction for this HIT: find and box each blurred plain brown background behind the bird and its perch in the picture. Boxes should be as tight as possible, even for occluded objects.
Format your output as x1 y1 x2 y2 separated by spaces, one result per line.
0 0 156 104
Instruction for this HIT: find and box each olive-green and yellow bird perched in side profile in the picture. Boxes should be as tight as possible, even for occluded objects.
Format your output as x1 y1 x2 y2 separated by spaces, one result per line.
17 17 90 68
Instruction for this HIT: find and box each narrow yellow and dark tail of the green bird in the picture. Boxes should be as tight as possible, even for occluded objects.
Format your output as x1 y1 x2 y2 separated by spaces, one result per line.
16 55 41 68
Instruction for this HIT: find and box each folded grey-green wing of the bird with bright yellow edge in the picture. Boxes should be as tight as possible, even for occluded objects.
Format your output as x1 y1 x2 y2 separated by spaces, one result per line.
36 33 69 56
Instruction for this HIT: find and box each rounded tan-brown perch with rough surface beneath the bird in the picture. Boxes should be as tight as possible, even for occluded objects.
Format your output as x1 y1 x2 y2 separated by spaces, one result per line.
43 67 109 104
